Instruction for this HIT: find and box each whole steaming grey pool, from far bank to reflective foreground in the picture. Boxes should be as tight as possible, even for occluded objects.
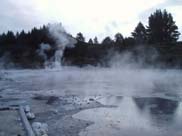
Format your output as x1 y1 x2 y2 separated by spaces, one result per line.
0 67 182 136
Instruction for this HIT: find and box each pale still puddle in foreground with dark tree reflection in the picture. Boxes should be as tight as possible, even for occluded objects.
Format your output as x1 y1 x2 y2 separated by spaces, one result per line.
73 97 182 136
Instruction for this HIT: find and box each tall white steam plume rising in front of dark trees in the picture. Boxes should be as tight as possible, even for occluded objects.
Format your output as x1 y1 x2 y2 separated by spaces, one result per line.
37 24 76 69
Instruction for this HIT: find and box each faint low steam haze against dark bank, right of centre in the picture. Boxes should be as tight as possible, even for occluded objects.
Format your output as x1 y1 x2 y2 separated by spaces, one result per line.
106 46 159 69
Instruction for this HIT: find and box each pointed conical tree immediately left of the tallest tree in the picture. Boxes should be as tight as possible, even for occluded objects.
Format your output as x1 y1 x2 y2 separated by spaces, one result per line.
132 22 147 44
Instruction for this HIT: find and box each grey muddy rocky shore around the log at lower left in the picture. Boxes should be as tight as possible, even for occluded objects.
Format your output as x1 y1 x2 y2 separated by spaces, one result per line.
0 95 111 136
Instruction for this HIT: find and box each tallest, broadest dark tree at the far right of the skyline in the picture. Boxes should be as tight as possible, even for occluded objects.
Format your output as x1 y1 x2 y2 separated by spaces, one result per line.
147 10 180 43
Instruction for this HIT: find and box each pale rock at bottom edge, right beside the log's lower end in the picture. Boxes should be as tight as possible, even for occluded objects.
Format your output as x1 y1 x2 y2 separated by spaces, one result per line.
32 122 48 136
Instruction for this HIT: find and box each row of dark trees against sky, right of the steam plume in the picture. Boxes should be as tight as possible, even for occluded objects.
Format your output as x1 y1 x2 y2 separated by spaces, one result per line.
76 10 180 44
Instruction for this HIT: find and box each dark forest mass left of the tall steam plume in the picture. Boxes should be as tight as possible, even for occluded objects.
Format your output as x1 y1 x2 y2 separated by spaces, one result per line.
0 26 54 67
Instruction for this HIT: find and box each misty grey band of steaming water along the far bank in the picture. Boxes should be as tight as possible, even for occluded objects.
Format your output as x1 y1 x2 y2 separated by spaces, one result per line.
0 67 182 99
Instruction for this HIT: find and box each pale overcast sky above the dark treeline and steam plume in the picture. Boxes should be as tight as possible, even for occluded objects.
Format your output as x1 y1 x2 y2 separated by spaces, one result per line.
0 0 182 40
